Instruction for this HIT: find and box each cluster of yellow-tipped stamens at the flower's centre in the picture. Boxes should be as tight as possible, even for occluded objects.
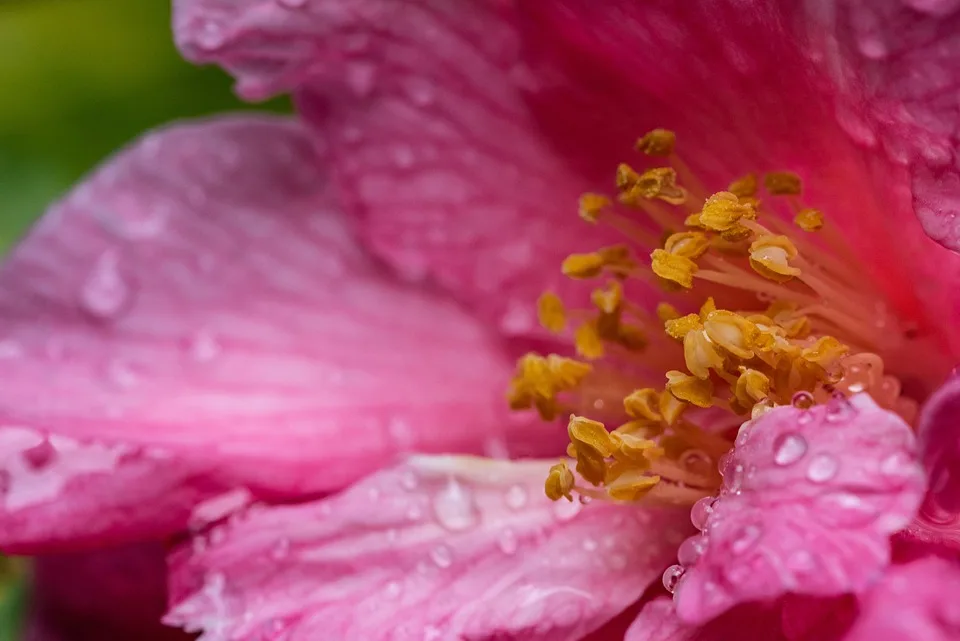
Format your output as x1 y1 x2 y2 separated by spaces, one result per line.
508 129 944 504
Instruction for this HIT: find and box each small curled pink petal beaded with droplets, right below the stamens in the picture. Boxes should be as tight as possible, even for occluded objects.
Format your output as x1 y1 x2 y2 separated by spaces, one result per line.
675 394 924 623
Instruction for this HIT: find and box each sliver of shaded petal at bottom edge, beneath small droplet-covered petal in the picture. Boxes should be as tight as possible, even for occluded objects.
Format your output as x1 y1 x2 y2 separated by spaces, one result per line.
624 598 792 641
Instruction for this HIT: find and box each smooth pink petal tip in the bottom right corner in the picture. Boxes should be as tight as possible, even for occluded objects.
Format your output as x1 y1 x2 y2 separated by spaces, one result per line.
844 557 960 641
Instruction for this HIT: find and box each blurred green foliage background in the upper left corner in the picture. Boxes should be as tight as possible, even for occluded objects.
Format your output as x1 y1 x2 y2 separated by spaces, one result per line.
0 0 288 249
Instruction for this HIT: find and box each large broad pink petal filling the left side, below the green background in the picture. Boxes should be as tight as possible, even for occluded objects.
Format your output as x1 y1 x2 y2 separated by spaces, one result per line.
0 116 547 551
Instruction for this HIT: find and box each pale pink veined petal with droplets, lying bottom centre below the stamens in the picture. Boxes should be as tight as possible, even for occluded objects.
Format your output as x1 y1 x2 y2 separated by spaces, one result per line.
165 457 689 641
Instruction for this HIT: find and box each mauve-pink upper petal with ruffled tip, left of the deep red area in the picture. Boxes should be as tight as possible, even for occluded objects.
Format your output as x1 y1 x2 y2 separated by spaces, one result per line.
175 0 630 335
